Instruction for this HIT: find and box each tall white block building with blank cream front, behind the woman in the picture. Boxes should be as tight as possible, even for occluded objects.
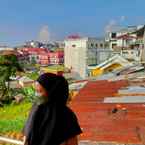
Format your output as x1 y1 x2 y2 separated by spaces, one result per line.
64 37 105 78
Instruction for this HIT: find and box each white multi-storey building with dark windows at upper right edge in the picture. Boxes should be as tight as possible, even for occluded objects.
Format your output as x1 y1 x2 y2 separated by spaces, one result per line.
106 25 145 61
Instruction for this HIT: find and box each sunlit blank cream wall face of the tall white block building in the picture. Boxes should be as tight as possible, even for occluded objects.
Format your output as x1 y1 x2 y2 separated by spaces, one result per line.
64 39 88 78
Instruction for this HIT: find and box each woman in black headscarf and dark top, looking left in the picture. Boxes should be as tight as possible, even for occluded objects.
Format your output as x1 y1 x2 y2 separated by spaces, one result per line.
23 73 82 145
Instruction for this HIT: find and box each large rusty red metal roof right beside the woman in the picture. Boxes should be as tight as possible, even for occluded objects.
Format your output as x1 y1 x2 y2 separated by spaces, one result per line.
70 81 145 143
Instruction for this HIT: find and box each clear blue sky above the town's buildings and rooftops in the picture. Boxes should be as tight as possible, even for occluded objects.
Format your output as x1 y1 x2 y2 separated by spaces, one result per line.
0 0 145 45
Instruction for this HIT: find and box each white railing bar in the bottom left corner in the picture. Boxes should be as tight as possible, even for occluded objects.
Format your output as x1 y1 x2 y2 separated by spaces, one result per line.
0 136 23 145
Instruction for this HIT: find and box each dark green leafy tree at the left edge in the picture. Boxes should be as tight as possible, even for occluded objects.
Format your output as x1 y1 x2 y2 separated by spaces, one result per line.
0 54 23 102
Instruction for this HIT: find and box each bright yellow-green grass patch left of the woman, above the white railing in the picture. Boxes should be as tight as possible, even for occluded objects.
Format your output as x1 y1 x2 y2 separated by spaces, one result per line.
0 102 31 135
